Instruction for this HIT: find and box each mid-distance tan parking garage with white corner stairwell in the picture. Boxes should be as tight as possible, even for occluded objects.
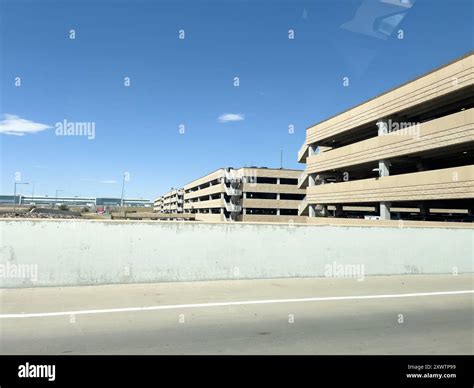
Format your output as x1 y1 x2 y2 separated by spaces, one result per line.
184 167 305 222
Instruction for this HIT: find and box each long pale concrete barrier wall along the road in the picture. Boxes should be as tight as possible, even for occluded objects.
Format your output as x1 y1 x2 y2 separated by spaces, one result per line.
0 220 474 287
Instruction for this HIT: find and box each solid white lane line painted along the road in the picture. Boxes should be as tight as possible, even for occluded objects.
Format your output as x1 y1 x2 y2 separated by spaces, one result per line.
0 290 474 319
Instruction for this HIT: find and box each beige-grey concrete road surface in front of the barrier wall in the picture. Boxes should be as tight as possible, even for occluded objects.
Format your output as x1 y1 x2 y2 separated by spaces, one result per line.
0 274 474 355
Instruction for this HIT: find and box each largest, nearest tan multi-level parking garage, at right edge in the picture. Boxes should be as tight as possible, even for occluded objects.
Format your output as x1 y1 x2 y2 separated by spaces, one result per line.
298 53 474 220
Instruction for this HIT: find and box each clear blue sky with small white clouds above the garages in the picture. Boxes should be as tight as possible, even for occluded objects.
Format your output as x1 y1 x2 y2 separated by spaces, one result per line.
0 0 473 199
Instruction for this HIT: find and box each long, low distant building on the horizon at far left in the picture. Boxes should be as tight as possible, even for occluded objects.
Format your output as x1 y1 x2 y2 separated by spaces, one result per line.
0 195 153 207
